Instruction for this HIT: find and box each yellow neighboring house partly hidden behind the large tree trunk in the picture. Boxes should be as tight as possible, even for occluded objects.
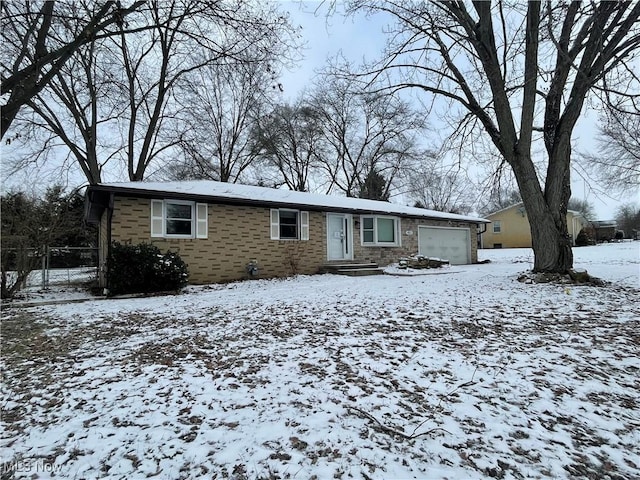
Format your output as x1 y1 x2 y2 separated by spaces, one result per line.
481 203 589 248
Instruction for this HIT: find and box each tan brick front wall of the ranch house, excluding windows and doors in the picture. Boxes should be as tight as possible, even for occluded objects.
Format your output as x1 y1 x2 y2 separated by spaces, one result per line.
100 196 478 284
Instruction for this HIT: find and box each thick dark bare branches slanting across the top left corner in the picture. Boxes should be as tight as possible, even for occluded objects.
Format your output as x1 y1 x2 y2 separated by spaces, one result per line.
0 1 146 138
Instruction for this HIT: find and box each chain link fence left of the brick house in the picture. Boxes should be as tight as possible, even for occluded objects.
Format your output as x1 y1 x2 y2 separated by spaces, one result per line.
2 246 98 288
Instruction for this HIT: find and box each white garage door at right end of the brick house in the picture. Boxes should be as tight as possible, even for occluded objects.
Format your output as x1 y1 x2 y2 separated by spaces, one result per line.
418 227 471 265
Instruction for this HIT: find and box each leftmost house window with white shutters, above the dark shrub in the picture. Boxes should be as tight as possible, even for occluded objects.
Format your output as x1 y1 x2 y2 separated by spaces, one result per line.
151 200 208 238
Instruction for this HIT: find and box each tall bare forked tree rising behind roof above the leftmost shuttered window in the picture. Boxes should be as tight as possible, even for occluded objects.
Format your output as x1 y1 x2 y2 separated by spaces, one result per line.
109 0 296 181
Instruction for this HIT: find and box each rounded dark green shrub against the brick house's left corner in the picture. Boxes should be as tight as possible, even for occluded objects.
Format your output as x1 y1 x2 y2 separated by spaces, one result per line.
107 242 189 295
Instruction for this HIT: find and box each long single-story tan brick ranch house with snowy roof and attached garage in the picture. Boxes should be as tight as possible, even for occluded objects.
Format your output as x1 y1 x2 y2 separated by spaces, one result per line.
86 181 487 286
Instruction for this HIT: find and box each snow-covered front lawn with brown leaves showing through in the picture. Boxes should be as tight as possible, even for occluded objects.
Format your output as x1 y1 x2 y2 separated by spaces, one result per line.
0 242 640 480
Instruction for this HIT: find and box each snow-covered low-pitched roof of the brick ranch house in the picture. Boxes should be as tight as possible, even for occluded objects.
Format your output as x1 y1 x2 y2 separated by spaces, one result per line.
87 180 490 223
